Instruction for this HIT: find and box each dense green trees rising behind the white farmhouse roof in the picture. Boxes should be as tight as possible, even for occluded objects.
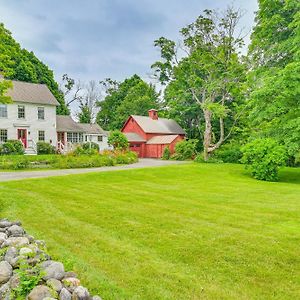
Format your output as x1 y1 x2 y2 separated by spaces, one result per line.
0 24 69 114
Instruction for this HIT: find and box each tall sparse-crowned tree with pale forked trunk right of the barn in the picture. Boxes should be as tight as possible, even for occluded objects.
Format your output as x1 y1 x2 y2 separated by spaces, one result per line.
152 8 245 160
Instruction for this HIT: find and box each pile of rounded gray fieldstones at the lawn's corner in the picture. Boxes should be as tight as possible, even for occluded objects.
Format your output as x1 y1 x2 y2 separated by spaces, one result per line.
0 219 101 300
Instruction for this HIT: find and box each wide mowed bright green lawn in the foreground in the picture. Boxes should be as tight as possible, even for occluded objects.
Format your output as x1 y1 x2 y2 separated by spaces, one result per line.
0 164 300 300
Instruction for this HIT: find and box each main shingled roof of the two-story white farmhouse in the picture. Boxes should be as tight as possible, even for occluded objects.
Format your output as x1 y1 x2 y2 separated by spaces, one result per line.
7 80 59 106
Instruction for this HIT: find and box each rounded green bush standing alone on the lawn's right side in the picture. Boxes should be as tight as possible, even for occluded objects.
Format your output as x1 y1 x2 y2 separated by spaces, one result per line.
241 138 287 181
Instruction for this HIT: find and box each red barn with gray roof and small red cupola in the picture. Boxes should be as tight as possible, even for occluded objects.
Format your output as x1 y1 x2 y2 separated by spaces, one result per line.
122 109 185 158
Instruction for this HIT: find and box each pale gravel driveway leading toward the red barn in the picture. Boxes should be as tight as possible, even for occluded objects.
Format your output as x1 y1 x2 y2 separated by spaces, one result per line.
0 158 184 182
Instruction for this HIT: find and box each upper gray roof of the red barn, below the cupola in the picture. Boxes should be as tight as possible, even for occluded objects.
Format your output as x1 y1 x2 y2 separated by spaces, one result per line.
132 115 185 134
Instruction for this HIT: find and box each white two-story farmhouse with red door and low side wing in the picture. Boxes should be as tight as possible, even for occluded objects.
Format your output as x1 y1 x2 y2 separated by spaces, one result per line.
0 78 109 154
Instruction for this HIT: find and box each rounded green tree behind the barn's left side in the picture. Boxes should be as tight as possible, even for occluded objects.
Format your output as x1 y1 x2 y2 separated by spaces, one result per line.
97 75 159 130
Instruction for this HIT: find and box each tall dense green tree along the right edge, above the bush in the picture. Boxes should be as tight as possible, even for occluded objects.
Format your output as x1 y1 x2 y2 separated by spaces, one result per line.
249 0 300 157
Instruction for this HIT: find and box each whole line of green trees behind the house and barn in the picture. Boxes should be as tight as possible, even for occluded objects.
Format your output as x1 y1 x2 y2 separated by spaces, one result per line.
0 0 300 165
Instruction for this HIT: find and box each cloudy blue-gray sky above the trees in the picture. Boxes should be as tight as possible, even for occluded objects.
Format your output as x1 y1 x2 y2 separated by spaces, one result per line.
0 0 257 81
